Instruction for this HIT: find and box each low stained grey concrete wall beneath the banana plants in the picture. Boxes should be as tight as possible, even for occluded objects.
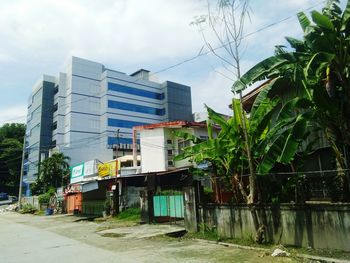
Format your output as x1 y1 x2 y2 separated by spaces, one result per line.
198 204 350 251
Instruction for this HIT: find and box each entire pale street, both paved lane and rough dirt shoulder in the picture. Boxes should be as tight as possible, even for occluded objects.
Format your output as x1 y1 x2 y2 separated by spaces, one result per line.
0 212 297 263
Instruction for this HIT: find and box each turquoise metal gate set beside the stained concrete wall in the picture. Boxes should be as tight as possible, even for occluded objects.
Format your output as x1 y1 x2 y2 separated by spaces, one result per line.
153 195 185 221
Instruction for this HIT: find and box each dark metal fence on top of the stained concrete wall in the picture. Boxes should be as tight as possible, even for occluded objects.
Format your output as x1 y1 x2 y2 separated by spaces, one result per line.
200 170 350 203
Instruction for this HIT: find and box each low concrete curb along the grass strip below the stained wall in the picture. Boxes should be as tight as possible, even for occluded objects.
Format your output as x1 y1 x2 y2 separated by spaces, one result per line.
194 238 349 263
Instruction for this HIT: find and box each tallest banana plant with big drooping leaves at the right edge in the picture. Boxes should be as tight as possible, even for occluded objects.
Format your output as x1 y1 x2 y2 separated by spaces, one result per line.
233 0 350 200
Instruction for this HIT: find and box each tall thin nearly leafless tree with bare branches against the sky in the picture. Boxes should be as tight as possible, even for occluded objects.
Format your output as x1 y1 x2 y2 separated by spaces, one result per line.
194 0 256 203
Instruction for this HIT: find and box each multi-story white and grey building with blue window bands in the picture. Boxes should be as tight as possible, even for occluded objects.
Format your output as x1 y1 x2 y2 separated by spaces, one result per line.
24 57 192 196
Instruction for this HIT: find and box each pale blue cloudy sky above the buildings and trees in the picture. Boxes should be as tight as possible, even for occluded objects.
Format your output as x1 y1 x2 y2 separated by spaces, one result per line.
0 0 345 125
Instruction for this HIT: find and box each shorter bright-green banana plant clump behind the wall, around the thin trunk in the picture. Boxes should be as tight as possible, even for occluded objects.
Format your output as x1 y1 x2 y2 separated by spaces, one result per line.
176 79 309 203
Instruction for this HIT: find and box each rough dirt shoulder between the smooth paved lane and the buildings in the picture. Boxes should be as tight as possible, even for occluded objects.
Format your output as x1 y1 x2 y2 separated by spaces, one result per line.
0 212 310 263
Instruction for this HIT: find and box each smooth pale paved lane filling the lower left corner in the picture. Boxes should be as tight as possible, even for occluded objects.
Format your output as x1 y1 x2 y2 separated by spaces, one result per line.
0 213 124 263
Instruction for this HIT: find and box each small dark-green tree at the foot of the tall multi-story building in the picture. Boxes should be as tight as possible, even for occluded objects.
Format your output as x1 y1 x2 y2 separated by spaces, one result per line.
32 153 70 194
